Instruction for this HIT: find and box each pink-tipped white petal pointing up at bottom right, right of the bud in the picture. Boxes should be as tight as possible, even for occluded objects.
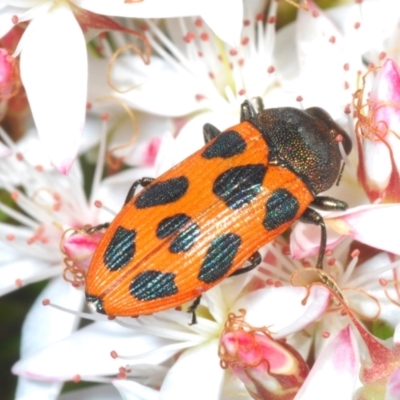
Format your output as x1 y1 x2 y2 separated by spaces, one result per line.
296 326 360 400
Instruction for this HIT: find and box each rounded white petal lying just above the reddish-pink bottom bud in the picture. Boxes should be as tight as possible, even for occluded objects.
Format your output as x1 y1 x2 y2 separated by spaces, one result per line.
232 285 330 338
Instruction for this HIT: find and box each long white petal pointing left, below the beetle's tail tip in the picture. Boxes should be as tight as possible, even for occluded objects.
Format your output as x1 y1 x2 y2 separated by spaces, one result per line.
13 321 173 381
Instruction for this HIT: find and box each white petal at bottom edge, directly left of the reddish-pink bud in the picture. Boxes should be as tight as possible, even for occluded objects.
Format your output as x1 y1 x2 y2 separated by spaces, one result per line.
160 339 225 400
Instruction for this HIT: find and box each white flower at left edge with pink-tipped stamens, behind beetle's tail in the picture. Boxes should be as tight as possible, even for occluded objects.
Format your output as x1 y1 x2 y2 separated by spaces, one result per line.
0 120 155 398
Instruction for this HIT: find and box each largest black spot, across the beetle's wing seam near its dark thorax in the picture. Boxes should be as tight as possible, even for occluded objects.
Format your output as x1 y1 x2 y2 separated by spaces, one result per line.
213 164 267 209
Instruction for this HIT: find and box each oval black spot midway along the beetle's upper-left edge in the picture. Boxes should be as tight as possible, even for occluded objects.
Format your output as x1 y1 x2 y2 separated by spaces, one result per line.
135 176 189 208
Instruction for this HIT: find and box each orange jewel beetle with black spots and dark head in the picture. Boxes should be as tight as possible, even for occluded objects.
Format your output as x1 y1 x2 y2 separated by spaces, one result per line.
86 100 352 318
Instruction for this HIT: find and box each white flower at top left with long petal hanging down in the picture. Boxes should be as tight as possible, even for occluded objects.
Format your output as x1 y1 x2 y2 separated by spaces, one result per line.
0 0 242 174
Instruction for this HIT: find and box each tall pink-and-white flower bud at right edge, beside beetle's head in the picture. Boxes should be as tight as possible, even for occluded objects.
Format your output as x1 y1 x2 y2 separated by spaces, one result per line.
355 59 400 202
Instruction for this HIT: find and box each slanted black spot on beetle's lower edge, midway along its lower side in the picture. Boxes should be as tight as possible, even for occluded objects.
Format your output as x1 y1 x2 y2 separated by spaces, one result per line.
198 233 242 283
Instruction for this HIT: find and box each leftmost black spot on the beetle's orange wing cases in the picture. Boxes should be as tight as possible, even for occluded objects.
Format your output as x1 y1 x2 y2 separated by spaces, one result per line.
104 226 136 271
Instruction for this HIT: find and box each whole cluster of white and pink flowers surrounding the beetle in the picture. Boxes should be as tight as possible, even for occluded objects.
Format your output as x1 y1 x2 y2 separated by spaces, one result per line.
0 0 400 400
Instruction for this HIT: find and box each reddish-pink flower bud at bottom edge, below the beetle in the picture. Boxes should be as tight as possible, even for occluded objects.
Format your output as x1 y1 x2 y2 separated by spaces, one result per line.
219 310 309 400
